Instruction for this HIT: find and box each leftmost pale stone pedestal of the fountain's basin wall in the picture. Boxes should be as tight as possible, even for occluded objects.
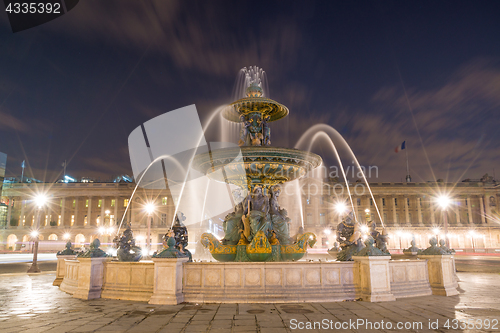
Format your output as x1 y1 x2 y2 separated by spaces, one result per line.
73 257 111 300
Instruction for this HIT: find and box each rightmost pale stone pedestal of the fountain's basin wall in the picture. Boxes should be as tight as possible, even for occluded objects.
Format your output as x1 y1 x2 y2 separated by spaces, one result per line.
418 255 458 296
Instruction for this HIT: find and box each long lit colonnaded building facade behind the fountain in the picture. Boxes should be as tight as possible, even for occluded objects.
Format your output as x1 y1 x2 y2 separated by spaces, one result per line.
0 178 500 252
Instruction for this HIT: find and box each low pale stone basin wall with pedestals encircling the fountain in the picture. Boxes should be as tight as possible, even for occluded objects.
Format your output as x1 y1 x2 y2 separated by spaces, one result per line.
58 255 458 304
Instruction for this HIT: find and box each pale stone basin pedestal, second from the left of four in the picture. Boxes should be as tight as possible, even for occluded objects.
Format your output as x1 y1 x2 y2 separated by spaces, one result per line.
149 258 189 304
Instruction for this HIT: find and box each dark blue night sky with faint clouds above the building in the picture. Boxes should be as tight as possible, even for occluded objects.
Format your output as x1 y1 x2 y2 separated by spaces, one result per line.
0 0 500 182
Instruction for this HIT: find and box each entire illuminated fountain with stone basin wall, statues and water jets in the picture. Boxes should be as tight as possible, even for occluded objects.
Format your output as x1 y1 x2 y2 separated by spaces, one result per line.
54 67 458 304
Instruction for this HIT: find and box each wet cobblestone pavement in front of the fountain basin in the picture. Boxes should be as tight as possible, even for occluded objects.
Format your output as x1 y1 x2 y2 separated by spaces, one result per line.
0 273 500 333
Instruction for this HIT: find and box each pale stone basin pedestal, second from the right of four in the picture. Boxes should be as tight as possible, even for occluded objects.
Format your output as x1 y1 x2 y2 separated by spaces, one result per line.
352 256 396 302
